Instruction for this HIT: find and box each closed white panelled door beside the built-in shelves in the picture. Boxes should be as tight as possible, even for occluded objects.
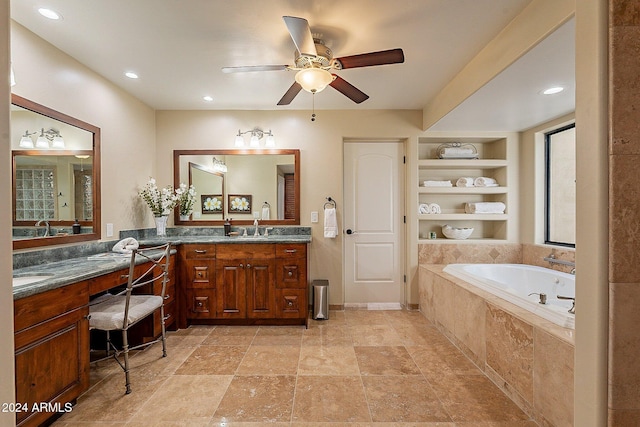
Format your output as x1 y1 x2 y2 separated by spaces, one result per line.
343 142 404 308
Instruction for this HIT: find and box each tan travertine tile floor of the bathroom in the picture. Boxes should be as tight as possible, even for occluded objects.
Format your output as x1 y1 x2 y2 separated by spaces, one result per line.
53 310 536 427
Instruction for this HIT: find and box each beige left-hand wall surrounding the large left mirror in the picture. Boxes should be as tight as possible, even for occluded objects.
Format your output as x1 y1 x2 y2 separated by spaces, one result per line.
11 21 156 240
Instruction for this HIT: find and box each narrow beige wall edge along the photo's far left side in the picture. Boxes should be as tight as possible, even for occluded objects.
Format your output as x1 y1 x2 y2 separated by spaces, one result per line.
0 0 15 426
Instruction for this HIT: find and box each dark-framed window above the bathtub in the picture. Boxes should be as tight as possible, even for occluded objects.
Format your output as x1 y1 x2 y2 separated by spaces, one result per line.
544 124 576 247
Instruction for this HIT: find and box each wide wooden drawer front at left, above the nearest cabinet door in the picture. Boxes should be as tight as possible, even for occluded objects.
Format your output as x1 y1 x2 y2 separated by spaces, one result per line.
13 281 89 331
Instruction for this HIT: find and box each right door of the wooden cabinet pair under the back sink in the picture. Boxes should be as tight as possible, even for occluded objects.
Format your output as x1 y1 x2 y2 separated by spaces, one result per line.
246 259 276 319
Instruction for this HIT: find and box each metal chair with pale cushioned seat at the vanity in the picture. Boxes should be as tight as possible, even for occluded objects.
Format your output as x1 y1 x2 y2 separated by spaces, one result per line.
89 243 171 394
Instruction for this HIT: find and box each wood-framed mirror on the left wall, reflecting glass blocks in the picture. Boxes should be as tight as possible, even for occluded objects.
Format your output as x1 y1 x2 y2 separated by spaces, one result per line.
11 94 100 249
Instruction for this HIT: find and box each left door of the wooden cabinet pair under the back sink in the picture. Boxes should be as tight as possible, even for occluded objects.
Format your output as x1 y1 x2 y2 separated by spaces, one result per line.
216 259 247 319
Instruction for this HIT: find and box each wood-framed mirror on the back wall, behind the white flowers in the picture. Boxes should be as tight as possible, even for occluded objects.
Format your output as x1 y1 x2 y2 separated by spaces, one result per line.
173 149 300 225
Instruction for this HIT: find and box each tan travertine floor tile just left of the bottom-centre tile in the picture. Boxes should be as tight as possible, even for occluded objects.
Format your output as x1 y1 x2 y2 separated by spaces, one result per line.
213 375 296 425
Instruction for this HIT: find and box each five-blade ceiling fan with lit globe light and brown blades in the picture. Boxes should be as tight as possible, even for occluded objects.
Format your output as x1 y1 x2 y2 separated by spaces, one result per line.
222 16 404 105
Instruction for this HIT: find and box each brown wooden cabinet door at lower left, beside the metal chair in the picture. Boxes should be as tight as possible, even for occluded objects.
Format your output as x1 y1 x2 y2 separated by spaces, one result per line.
15 306 89 426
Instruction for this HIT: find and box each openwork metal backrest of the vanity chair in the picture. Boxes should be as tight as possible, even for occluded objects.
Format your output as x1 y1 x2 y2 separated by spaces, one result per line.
120 243 171 328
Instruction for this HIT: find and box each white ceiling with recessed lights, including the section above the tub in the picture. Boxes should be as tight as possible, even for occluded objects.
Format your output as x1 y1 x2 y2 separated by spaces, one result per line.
11 0 575 130
